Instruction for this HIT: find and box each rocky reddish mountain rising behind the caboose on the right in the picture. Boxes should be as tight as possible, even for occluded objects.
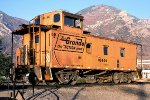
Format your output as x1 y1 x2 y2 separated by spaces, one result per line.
78 5 150 59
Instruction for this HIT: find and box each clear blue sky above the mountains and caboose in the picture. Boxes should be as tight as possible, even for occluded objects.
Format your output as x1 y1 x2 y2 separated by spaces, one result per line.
0 0 150 20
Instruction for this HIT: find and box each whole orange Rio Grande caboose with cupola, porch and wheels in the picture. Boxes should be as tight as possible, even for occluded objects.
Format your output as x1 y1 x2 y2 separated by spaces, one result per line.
13 11 141 85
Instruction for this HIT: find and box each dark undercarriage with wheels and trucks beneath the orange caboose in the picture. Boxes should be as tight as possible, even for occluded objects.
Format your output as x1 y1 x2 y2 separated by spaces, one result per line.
15 67 138 85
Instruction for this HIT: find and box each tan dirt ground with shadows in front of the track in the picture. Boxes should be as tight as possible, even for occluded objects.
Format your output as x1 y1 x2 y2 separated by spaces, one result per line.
24 84 150 100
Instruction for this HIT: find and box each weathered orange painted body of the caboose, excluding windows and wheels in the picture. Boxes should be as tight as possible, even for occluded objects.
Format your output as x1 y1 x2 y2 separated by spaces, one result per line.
16 11 137 80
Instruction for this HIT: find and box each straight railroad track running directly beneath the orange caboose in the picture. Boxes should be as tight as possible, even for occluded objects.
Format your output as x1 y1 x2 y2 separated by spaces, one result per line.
0 82 150 91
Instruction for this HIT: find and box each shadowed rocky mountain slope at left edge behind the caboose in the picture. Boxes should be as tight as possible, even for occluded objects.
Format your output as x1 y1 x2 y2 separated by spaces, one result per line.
0 11 28 54
